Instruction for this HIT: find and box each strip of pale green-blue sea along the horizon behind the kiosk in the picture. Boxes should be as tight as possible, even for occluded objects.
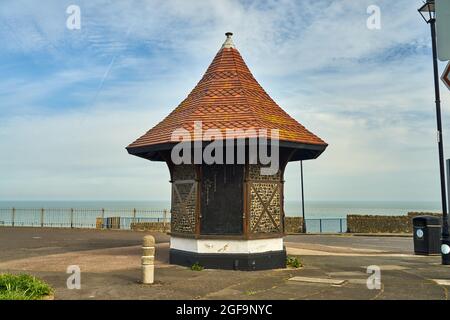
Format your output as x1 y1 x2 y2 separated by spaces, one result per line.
0 200 440 219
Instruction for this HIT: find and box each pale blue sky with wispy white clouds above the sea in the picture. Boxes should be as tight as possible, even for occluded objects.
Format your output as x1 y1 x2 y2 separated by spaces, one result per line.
0 0 450 201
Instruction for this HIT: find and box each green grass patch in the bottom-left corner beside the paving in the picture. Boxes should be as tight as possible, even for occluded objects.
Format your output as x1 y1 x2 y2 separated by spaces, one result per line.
0 273 53 300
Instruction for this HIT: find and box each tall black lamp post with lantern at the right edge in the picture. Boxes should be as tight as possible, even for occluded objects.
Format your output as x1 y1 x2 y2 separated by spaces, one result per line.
419 0 450 265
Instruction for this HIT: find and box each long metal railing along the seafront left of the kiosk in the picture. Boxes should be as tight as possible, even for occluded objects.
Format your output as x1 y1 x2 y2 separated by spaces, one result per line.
0 208 170 229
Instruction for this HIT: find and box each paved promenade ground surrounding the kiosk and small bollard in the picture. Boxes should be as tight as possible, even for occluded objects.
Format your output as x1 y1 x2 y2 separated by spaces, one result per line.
0 227 450 300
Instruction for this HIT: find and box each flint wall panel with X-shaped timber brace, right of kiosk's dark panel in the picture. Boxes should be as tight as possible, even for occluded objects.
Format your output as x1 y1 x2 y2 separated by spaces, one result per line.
249 165 283 233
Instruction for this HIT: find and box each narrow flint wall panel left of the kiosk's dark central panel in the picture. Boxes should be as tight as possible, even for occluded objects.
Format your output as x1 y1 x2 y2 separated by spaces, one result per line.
171 165 197 234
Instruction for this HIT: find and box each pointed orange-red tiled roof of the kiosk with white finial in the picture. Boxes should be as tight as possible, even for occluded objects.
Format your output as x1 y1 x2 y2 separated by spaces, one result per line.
127 33 326 156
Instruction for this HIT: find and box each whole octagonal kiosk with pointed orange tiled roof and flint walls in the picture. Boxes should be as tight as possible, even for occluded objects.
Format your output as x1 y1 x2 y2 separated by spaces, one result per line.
127 33 327 270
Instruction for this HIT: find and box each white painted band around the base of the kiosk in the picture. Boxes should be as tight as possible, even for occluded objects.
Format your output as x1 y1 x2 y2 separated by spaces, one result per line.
170 237 283 253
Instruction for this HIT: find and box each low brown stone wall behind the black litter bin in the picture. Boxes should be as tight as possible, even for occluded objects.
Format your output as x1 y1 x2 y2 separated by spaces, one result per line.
347 212 441 233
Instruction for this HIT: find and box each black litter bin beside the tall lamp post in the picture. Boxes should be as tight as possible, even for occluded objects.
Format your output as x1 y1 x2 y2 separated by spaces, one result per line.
413 216 441 255
